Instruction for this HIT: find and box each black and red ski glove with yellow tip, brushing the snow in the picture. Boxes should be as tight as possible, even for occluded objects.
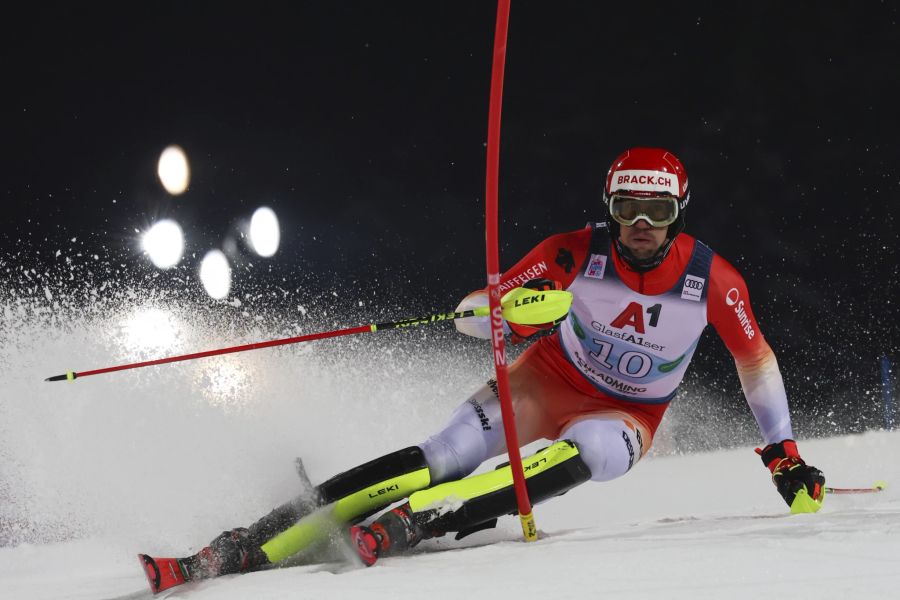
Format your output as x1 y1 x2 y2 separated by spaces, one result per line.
756 440 825 513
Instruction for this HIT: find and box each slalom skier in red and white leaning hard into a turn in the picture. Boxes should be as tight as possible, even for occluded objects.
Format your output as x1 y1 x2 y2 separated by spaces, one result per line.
139 148 825 583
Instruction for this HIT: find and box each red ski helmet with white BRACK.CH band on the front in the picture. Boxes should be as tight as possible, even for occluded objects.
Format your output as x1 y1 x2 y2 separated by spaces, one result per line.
603 148 691 271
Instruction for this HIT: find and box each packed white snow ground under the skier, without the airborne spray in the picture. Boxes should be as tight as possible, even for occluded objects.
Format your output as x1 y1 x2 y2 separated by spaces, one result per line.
0 432 900 600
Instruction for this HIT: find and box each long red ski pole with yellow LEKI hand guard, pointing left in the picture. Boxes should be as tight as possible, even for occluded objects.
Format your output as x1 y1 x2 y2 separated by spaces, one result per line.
44 288 572 381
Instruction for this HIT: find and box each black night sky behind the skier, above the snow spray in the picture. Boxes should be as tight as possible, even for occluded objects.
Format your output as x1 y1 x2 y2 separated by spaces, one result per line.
0 0 900 418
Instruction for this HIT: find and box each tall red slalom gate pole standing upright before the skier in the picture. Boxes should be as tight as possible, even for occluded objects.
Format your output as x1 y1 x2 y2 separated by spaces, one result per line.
485 0 537 542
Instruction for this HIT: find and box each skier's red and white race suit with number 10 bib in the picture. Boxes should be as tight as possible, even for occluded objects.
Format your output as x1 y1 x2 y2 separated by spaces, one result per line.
421 223 793 480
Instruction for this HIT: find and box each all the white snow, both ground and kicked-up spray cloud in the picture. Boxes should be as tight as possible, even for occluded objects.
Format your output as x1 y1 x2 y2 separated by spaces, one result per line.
0 286 900 600
